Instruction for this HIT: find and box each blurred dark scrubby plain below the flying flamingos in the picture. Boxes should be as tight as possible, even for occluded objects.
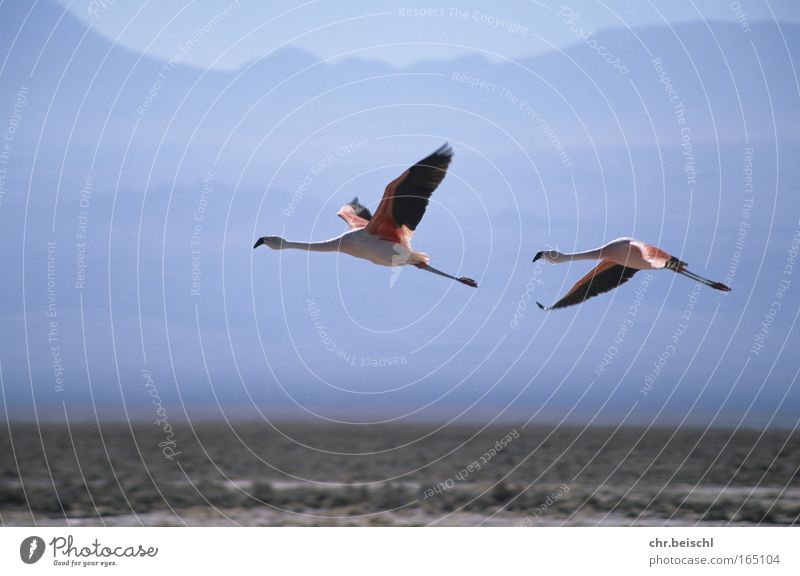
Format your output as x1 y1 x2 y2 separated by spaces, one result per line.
0 422 800 526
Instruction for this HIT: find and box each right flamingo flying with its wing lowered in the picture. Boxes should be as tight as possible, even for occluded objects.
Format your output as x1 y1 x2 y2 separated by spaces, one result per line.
533 238 731 310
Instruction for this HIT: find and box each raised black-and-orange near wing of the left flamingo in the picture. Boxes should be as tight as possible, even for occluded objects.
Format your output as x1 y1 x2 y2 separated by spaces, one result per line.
367 143 453 241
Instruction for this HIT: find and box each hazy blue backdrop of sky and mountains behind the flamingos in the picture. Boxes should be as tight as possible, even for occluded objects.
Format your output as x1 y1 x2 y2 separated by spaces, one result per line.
0 1 800 427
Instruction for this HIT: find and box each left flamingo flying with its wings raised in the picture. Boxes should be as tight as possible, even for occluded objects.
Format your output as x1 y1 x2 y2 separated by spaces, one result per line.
253 143 478 288
